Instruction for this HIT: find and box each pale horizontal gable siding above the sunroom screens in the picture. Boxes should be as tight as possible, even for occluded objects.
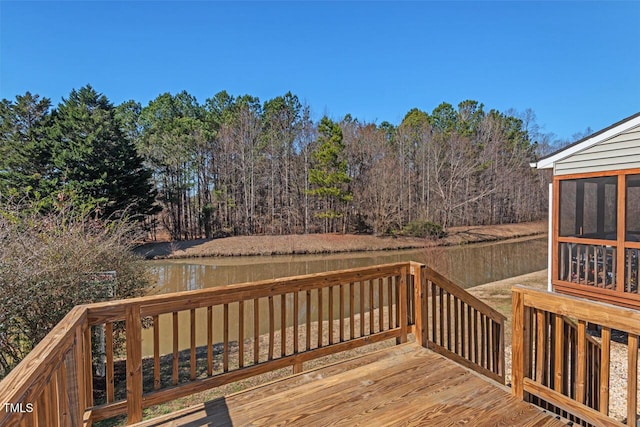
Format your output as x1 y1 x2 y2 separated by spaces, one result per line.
554 126 640 175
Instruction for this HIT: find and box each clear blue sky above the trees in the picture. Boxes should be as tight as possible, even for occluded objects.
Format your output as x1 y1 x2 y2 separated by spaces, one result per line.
0 0 640 139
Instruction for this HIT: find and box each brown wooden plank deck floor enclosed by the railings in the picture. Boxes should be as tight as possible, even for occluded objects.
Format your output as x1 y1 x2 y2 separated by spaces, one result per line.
136 343 566 427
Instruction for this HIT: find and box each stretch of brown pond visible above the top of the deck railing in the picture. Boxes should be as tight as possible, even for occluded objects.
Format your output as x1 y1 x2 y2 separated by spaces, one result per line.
149 236 547 293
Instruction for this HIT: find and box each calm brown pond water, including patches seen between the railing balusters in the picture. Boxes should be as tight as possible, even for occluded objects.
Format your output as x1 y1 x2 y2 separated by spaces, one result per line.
142 237 547 356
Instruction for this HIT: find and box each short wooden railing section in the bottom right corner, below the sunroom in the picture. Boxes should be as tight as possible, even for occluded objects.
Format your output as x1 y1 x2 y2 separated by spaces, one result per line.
512 286 640 426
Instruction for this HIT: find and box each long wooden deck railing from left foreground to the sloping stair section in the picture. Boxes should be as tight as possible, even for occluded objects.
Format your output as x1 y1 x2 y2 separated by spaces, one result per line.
0 262 504 426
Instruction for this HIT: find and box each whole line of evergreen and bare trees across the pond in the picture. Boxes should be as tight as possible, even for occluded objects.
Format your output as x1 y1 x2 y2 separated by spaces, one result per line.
0 86 548 240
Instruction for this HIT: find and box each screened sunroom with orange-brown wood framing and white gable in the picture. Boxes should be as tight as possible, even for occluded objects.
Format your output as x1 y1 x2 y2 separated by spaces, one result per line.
536 113 640 309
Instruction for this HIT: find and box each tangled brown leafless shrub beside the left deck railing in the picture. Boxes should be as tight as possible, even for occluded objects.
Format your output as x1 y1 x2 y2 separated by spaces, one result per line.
0 201 150 378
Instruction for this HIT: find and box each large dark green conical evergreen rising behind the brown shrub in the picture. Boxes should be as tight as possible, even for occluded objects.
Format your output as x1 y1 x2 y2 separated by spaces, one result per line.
49 85 155 216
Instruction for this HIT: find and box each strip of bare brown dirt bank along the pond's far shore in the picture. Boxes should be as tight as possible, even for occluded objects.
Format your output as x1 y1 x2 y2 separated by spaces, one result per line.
136 221 547 259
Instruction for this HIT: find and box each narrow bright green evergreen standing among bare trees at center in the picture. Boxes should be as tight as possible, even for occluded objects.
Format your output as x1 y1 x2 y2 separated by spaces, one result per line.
309 116 353 233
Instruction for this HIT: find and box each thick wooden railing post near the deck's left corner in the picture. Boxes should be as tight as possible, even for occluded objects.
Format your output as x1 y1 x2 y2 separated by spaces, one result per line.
125 305 142 424
